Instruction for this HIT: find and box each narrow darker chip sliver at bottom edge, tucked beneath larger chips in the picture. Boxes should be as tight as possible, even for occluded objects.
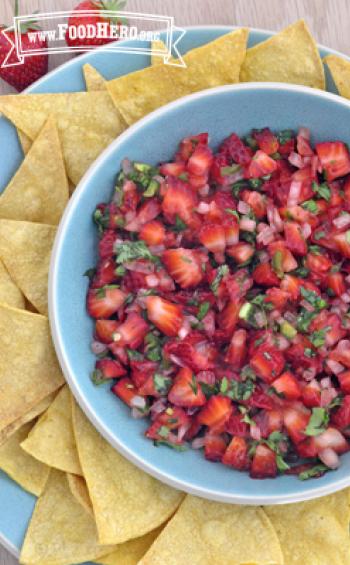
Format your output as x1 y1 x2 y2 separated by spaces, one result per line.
96 528 165 565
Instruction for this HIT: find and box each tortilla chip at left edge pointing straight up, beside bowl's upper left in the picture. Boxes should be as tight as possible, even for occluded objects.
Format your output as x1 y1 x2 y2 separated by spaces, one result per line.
0 118 69 225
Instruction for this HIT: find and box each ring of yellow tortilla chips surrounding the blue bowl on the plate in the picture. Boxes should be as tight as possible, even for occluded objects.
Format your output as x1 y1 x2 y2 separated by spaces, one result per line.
0 21 350 565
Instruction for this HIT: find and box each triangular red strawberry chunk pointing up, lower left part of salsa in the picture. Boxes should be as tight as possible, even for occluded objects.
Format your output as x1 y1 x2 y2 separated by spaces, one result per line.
168 367 206 408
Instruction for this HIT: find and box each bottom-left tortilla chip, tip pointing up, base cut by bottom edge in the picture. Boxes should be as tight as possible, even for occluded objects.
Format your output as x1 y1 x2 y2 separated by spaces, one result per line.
20 469 115 565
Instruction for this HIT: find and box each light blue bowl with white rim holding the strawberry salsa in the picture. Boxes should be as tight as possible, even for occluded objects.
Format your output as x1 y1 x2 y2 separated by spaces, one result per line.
49 83 350 504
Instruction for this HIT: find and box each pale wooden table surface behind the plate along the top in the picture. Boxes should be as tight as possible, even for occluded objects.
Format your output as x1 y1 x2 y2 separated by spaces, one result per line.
0 0 350 565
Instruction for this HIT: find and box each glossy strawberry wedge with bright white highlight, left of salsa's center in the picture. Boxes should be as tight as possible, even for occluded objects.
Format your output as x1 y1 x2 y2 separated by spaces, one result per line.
146 296 183 337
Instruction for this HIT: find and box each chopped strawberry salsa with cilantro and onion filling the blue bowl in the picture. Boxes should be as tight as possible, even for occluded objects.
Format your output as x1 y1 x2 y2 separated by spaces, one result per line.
87 128 350 479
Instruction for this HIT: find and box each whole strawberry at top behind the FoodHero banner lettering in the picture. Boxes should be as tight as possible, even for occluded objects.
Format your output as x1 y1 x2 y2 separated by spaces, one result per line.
66 0 126 48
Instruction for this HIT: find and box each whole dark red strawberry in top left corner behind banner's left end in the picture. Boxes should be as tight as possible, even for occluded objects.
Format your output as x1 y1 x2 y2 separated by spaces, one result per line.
0 2 49 92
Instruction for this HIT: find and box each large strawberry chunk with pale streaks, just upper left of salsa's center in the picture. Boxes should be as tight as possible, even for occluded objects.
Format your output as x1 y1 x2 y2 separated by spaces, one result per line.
162 247 203 288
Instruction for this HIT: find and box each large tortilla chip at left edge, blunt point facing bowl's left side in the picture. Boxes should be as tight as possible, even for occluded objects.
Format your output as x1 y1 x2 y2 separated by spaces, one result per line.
0 304 64 430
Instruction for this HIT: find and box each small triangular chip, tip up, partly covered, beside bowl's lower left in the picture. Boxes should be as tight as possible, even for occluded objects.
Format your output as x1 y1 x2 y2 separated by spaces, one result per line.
21 386 83 475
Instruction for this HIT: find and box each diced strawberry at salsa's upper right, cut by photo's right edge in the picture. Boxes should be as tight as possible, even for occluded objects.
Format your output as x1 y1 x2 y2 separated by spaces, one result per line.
315 141 350 181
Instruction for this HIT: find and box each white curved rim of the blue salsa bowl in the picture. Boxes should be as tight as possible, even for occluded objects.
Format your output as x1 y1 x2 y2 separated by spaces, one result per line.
48 82 350 505
